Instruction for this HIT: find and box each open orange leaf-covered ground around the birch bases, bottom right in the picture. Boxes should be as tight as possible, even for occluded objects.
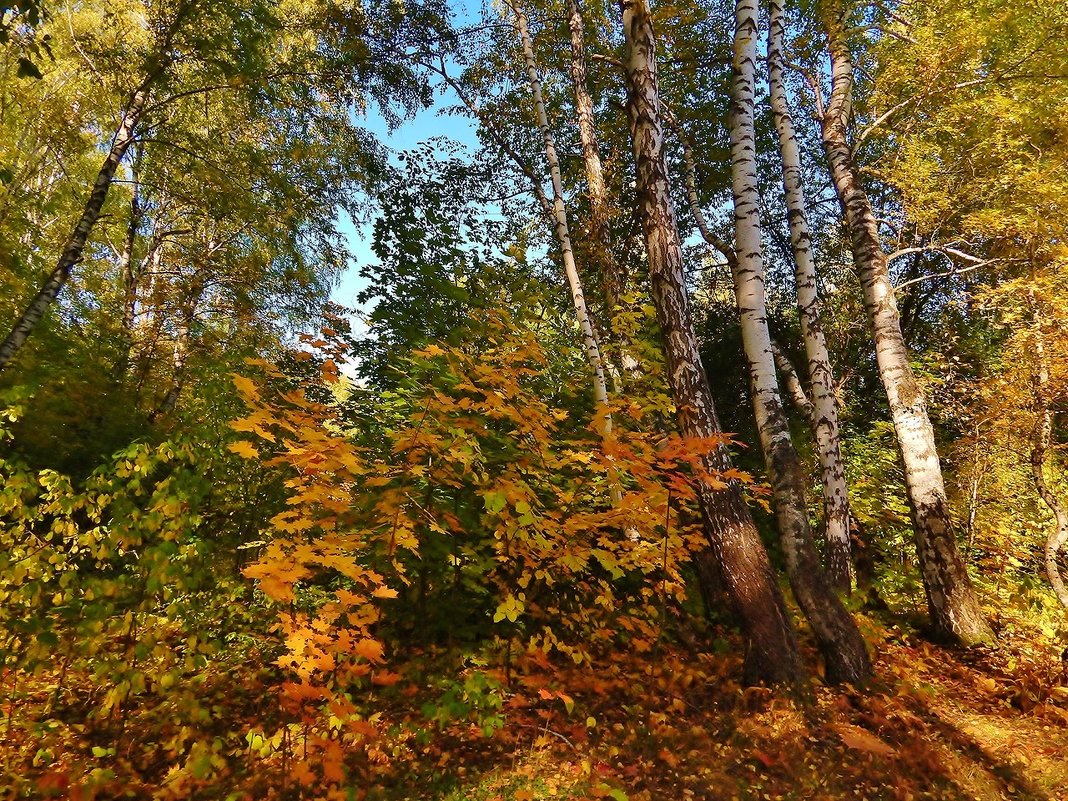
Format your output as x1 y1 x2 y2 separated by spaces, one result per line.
397 619 1068 801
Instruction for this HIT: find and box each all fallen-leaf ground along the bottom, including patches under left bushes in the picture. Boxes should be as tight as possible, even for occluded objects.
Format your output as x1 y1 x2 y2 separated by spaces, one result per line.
0 616 1068 801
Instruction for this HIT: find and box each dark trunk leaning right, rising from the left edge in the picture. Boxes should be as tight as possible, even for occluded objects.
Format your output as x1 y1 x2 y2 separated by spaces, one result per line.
0 81 148 371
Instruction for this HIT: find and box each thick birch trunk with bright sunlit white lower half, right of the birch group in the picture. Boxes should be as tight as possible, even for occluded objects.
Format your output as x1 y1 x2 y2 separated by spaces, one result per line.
820 0 993 645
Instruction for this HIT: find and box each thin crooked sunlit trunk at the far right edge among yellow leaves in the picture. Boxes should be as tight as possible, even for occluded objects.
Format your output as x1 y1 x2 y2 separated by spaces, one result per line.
1027 288 1068 609
